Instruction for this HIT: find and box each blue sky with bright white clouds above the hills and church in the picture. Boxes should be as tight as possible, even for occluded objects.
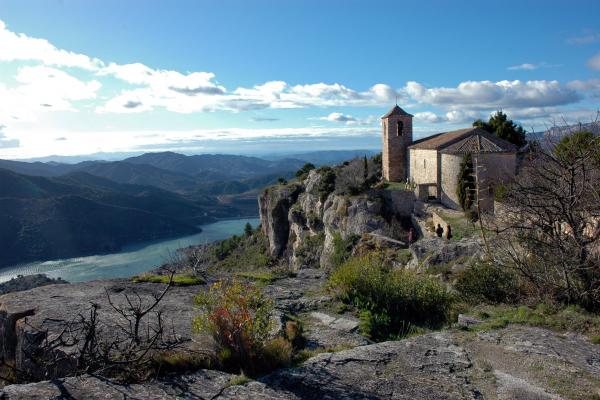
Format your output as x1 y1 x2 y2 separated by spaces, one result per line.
0 0 600 159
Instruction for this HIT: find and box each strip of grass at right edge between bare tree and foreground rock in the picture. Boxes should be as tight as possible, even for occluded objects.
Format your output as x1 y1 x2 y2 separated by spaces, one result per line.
466 303 600 343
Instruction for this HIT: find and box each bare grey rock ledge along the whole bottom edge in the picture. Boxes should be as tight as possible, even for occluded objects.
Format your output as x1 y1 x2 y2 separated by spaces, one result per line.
1 326 600 399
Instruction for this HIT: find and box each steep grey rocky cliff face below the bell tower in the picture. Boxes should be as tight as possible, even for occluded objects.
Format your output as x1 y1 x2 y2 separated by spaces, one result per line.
259 170 415 269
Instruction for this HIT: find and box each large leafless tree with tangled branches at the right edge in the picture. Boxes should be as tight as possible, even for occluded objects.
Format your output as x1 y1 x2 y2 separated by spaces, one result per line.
494 132 600 309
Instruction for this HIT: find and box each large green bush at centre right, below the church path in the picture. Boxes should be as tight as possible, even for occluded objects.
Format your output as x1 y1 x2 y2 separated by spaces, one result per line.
330 252 453 341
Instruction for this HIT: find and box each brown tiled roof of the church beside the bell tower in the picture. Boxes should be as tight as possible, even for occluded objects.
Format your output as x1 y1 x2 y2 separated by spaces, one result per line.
409 127 517 154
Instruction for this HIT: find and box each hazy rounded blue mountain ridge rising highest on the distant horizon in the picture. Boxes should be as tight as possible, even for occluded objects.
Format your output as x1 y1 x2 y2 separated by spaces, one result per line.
123 152 305 181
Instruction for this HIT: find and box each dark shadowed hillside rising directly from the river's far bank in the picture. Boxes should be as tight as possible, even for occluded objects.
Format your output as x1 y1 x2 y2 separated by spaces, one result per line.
0 169 237 266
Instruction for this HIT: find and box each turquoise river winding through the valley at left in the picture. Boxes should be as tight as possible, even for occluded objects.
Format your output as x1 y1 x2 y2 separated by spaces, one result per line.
0 218 259 282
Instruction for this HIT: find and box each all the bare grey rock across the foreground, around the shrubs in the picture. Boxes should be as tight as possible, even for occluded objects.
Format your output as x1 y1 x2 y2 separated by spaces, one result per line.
0 270 600 399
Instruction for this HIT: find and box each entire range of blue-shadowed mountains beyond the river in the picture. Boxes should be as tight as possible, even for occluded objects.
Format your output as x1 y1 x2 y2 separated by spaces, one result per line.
0 152 376 267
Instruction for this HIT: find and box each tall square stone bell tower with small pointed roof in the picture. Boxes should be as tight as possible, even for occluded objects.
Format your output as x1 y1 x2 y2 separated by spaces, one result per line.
381 104 413 182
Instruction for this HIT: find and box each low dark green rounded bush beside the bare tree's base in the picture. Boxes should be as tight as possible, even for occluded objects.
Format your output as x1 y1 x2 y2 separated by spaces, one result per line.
454 263 521 304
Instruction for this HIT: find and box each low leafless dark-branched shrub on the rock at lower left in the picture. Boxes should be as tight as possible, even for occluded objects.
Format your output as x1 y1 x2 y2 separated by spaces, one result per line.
18 272 188 381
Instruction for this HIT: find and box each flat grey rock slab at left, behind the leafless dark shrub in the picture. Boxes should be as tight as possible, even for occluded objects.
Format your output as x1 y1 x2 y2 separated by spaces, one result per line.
0 279 201 379
